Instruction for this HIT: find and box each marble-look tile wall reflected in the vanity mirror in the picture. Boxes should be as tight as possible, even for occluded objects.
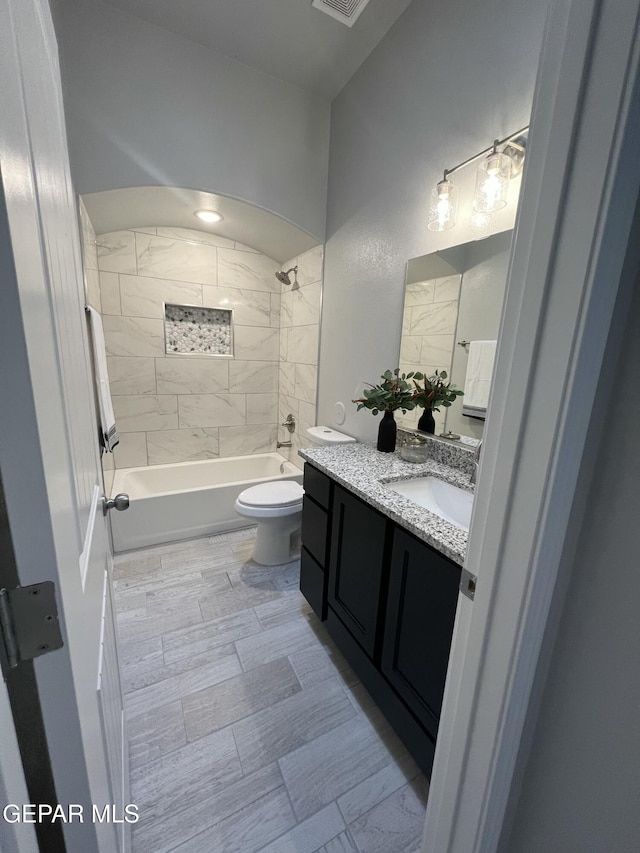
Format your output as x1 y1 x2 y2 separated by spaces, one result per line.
396 275 461 433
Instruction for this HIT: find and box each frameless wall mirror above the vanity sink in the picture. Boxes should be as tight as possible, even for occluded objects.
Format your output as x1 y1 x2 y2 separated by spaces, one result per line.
396 231 513 438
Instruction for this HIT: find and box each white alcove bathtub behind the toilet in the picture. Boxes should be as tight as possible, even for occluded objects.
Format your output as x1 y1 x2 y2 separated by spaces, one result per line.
109 453 302 552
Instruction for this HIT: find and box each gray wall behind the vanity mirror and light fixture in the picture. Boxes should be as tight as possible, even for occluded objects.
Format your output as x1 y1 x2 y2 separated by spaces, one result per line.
318 0 546 439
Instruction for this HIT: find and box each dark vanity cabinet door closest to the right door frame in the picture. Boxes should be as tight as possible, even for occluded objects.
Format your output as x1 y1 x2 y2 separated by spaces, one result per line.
382 528 460 739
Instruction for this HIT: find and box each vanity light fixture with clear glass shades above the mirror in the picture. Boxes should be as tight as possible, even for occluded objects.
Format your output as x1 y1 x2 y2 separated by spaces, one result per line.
427 126 529 231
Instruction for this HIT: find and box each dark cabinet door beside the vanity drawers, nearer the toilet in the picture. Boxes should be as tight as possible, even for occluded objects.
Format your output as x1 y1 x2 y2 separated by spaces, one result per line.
329 486 388 657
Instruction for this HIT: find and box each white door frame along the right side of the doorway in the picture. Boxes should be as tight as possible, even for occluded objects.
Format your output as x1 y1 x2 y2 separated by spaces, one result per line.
422 0 640 853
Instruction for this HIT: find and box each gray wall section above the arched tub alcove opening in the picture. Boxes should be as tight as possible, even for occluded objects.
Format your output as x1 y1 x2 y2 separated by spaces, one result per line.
51 0 329 240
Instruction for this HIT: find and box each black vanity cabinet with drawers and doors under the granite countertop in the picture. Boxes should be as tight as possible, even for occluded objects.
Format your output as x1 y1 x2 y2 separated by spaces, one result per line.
300 463 461 776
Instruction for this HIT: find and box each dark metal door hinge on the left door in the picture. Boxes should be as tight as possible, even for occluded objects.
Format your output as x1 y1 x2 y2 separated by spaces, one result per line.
0 581 63 669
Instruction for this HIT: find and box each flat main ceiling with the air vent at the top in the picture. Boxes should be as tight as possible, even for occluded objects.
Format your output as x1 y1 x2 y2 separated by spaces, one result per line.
107 0 411 100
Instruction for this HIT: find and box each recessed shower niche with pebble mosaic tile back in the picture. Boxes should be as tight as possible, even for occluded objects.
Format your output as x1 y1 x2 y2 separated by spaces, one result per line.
164 303 233 358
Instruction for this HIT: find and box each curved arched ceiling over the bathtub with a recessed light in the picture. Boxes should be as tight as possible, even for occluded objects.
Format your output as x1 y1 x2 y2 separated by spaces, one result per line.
82 187 318 263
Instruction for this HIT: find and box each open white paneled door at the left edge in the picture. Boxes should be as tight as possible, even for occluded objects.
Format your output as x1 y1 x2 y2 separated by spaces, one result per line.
0 0 129 853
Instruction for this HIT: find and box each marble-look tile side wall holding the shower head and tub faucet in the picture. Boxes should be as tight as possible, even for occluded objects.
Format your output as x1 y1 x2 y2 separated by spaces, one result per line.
278 246 323 468
